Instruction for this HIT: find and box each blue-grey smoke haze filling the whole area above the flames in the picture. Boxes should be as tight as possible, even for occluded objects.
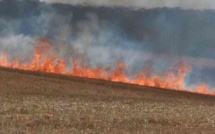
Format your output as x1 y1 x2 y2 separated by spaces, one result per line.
0 0 215 90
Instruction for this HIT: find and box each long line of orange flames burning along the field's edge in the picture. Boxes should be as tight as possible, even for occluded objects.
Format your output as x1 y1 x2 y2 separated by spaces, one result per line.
0 39 215 95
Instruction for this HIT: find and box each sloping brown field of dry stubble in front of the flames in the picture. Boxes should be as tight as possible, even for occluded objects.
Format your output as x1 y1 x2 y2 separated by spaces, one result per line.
0 68 215 134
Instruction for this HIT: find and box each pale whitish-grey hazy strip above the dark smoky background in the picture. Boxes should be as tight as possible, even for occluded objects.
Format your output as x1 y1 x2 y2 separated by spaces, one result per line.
40 0 215 10
